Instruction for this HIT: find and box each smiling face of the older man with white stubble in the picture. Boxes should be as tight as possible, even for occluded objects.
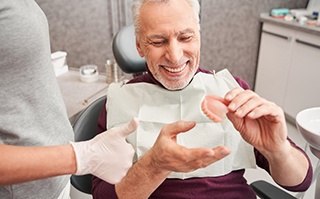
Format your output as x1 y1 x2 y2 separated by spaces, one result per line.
137 0 200 90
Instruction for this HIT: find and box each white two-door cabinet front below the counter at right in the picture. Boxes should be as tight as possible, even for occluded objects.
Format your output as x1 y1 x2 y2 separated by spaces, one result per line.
255 23 320 118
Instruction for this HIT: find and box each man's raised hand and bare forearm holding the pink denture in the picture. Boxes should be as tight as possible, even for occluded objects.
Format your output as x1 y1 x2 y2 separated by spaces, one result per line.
225 88 309 186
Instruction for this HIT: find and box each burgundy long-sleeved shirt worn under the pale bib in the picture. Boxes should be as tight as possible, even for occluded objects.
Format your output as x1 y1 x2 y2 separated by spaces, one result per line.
92 68 312 199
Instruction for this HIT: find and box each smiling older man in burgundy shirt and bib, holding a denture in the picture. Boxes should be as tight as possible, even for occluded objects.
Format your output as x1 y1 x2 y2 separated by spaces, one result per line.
93 0 312 199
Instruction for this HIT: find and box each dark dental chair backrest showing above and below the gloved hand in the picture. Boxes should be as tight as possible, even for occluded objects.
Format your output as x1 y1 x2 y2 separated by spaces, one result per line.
71 96 106 194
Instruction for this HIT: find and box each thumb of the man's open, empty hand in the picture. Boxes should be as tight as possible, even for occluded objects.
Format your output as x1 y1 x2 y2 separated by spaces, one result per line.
161 121 196 137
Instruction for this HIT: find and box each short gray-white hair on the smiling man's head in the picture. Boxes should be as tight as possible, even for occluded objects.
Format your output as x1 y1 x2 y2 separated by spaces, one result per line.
132 0 200 37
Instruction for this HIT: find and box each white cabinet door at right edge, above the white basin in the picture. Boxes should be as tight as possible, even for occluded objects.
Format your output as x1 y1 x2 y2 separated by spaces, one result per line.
283 32 320 117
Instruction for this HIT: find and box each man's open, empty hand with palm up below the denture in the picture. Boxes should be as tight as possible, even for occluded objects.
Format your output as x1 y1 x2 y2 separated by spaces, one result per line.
148 121 230 172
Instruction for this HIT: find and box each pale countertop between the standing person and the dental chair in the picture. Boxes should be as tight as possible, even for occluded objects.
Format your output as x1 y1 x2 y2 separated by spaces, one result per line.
57 69 109 123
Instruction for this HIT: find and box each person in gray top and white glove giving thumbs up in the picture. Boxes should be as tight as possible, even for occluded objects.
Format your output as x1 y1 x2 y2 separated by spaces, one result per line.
0 0 138 199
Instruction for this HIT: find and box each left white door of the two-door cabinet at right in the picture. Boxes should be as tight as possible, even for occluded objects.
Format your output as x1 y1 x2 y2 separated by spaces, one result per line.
255 23 293 106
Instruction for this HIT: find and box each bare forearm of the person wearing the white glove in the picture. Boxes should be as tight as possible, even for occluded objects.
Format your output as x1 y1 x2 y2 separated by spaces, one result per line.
0 144 77 186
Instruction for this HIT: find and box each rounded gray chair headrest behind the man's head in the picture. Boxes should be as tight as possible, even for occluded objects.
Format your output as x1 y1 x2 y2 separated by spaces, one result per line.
112 24 146 73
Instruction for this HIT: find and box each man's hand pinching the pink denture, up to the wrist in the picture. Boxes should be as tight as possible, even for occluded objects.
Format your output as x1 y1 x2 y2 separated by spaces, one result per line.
225 88 289 153
